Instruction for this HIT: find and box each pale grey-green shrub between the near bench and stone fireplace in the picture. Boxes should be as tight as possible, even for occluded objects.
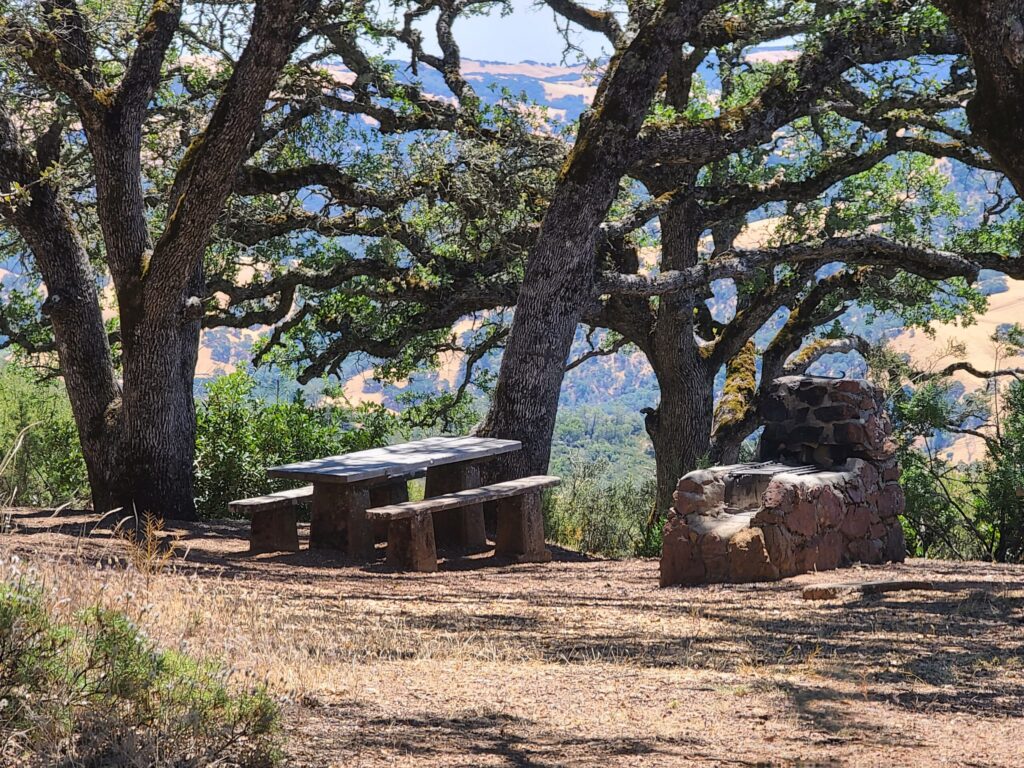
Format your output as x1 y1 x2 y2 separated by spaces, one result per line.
544 462 660 557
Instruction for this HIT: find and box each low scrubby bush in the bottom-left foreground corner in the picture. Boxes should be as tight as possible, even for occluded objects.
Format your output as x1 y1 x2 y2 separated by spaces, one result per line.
0 583 281 768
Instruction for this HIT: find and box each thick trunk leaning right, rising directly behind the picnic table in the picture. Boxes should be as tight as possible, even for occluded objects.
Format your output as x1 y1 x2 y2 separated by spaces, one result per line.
481 3 700 477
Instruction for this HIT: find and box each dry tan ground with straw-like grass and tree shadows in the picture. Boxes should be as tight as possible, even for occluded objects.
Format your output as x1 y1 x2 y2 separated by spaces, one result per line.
0 510 1024 768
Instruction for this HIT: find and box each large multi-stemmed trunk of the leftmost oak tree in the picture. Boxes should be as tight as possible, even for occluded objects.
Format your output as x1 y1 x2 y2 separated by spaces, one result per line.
0 0 315 518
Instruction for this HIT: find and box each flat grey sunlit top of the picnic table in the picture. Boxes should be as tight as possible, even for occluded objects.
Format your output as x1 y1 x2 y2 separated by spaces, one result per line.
266 437 522 482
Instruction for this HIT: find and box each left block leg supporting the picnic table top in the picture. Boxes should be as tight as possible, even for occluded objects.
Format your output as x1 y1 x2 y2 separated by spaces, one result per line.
309 482 374 560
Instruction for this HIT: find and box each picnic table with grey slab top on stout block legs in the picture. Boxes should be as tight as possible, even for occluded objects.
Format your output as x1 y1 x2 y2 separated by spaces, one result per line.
267 437 522 560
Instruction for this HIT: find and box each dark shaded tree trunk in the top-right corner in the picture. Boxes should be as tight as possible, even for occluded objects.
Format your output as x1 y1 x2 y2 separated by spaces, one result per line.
938 0 1024 196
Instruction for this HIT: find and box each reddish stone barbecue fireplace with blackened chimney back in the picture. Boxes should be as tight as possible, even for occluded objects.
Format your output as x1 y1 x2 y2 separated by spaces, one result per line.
662 376 906 587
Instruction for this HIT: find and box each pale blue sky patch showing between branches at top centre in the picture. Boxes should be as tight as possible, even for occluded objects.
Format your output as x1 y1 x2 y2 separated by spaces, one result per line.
421 0 607 62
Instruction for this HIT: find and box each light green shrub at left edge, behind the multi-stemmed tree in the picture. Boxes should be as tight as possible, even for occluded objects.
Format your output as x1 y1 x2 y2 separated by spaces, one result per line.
0 361 89 507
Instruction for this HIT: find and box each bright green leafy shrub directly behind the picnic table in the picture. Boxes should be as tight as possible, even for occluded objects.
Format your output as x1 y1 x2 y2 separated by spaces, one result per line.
196 371 394 517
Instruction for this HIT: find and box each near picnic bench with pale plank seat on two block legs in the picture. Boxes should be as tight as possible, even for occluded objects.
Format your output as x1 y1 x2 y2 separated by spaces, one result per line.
367 475 560 572
